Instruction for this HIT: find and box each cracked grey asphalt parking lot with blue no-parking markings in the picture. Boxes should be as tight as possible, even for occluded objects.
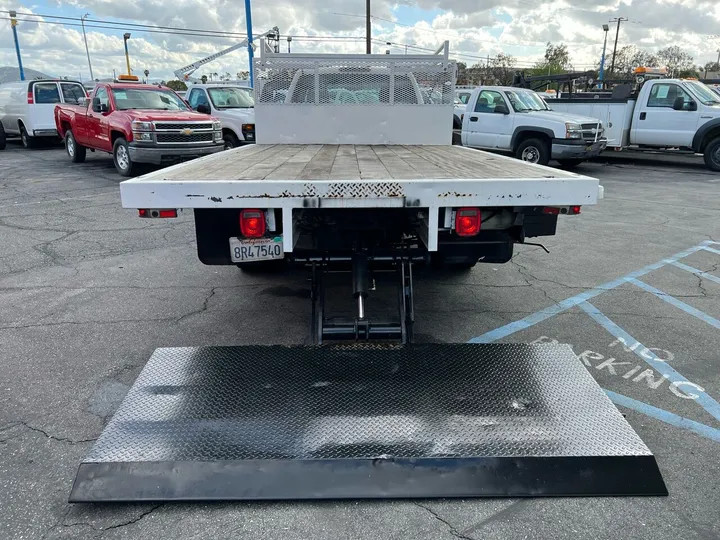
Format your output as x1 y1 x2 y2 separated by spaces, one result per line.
0 142 720 540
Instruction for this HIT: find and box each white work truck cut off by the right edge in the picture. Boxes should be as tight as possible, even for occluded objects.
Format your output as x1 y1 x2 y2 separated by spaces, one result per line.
548 79 720 171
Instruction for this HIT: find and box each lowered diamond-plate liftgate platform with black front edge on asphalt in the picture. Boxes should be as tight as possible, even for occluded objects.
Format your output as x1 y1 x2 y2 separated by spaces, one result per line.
70 344 667 502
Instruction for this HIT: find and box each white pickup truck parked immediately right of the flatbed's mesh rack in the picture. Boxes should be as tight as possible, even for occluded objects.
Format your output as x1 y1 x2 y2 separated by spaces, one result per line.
461 86 607 167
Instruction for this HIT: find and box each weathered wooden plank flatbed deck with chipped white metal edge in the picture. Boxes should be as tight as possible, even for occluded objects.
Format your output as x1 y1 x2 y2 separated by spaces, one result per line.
120 144 602 208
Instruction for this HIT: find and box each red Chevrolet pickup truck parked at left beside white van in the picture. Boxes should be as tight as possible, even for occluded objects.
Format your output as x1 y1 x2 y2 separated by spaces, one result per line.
55 83 224 176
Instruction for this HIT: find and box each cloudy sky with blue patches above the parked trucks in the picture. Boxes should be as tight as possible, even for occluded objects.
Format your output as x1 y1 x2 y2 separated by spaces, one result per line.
0 0 720 80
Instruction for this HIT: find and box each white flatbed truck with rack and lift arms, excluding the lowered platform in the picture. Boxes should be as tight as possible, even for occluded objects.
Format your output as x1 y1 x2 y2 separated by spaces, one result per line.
120 45 602 342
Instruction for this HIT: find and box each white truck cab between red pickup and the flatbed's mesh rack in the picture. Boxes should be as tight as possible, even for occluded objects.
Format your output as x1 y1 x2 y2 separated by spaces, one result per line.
185 82 255 149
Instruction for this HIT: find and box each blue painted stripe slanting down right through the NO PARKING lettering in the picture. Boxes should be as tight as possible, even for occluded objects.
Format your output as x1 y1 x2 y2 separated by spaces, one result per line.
578 302 720 420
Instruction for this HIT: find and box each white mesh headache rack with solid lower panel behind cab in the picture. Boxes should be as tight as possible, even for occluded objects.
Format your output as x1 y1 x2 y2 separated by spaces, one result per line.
254 43 456 145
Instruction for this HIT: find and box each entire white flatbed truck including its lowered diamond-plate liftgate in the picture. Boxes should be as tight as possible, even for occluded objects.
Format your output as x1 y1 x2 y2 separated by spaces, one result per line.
70 44 667 502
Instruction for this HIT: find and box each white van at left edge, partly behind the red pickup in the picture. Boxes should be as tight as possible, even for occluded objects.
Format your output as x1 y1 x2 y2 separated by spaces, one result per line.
0 79 87 148
